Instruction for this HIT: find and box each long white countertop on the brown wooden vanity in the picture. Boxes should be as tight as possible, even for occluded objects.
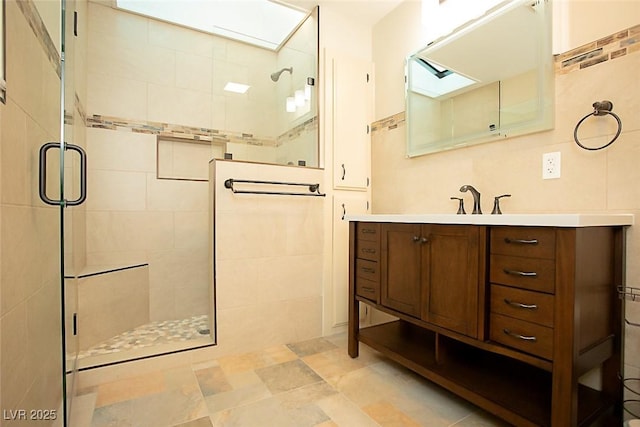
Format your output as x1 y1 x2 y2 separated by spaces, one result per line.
345 214 633 227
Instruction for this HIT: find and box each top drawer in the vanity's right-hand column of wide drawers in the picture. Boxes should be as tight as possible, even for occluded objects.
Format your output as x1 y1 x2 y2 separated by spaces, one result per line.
491 227 556 259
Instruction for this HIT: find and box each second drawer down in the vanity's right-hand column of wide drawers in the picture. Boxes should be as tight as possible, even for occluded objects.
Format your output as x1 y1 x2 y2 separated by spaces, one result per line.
489 254 556 294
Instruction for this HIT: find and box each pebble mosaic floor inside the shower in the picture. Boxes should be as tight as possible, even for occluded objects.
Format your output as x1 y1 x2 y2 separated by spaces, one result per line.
78 314 210 359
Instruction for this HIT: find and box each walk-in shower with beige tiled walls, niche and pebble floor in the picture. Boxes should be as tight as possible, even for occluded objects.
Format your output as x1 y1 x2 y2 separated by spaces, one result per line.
73 2 319 369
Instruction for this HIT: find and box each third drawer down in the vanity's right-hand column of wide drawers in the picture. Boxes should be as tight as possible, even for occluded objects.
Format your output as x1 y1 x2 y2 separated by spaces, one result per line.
491 285 554 328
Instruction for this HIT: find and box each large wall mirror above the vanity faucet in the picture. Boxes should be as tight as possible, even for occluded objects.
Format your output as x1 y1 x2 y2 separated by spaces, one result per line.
406 0 554 157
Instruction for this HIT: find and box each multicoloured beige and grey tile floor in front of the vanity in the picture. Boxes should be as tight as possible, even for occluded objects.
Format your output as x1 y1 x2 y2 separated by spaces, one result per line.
72 335 506 427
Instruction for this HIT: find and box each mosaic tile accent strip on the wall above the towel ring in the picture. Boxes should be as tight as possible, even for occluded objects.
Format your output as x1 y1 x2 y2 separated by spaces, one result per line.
554 25 640 74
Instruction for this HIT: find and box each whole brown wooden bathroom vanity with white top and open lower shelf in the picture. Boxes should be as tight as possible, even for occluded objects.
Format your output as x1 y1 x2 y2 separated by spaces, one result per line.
347 214 633 427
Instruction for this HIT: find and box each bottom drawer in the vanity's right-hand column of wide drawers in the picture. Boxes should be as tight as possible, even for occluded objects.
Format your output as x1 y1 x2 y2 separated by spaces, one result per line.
489 313 553 360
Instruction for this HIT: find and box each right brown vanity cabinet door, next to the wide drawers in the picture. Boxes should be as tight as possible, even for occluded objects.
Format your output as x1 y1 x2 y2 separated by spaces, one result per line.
420 225 480 338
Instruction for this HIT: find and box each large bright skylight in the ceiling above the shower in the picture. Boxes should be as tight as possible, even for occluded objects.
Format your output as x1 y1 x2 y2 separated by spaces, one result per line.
116 0 307 50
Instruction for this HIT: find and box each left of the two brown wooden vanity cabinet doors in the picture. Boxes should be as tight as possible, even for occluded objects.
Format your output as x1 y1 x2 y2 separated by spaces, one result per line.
380 224 422 317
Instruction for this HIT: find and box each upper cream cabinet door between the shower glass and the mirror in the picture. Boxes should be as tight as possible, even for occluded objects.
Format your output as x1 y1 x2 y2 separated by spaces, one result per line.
331 51 373 190
